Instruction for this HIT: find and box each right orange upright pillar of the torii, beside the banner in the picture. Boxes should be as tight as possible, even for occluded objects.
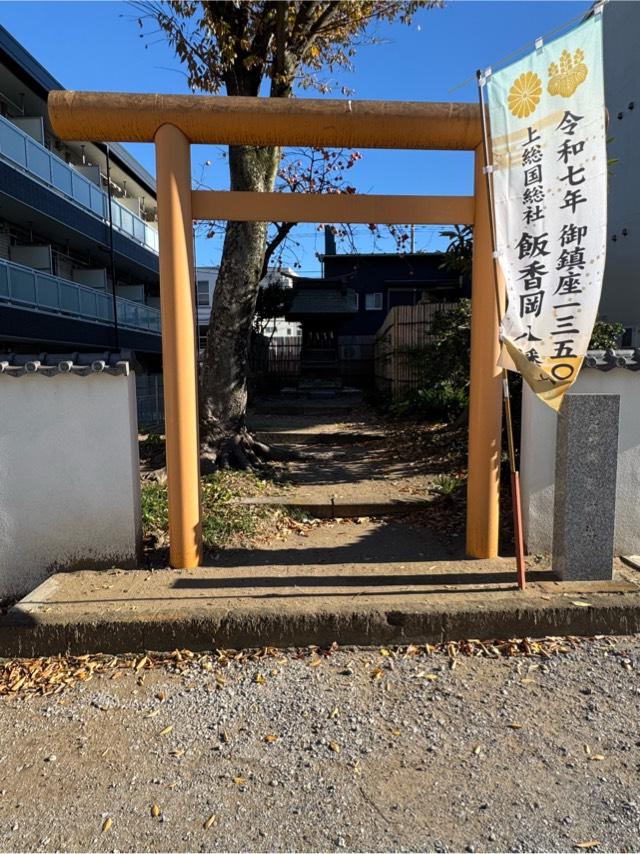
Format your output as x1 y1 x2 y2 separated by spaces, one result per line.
467 145 502 558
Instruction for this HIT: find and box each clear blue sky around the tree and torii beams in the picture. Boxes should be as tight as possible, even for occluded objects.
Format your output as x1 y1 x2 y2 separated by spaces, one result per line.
0 0 591 274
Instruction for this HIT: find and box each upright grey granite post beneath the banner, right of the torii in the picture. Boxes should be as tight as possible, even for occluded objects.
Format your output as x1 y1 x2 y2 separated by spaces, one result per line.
552 394 620 581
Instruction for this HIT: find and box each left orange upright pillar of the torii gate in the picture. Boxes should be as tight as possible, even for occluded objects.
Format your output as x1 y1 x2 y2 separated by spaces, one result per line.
155 124 202 567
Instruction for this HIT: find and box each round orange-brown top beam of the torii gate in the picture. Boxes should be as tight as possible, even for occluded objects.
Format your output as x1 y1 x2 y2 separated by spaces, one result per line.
49 91 482 151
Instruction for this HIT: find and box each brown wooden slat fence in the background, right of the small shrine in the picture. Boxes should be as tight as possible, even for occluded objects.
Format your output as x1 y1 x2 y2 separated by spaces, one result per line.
374 302 455 399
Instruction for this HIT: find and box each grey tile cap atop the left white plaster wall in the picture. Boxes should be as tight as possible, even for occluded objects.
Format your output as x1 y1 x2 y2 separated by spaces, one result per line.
0 350 140 377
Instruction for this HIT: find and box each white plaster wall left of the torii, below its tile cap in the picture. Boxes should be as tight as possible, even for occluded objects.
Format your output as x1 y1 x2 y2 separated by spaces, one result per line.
0 373 141 598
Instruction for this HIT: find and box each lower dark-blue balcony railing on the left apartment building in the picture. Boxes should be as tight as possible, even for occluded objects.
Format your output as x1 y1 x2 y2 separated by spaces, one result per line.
0 259 160 335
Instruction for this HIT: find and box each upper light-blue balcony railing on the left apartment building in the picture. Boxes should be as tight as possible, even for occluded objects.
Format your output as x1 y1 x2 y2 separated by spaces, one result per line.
0 116 158 253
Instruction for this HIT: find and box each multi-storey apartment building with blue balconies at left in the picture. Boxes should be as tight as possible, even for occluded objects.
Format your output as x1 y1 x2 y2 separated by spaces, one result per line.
0 27 161 373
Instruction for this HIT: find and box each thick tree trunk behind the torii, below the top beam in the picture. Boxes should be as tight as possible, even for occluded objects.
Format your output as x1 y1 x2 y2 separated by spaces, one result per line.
200 146 280 468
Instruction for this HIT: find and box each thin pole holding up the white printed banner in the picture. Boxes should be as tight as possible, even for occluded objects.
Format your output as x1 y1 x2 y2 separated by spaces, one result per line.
477 71 527 590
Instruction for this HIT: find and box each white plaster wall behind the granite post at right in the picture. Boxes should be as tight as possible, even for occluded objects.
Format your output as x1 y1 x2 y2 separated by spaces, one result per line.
520 368 640 555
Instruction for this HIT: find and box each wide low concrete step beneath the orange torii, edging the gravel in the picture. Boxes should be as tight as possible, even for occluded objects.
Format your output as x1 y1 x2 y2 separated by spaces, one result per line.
0 560 640 657
